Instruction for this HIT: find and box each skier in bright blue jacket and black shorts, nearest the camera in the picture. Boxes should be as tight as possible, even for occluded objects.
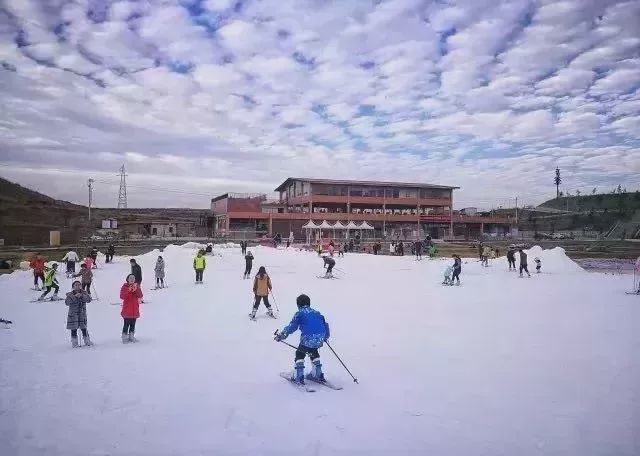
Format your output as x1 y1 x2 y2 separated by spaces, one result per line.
275 294 330 385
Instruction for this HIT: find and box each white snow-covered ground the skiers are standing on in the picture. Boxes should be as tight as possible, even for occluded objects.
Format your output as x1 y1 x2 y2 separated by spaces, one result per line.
0 246 640 456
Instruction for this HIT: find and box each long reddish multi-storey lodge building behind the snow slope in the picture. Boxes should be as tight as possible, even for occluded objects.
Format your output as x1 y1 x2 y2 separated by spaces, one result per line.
211 177 513 239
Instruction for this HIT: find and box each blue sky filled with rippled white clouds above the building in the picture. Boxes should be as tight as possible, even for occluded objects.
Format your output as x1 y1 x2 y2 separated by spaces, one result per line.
0 0 640 208
